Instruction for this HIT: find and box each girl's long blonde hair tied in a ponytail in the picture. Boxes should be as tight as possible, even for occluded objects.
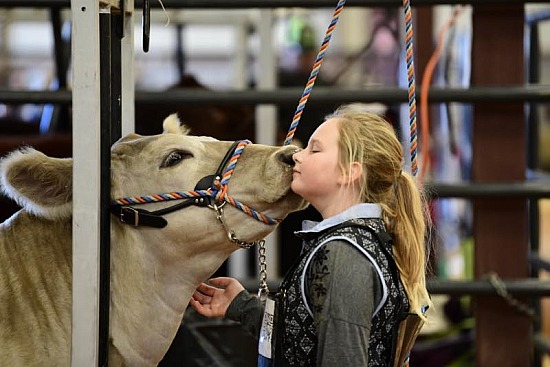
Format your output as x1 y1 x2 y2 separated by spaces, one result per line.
327 104 432 318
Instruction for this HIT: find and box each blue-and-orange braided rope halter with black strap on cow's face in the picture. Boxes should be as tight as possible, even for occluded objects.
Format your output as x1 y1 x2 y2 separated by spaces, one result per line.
111 140 282 249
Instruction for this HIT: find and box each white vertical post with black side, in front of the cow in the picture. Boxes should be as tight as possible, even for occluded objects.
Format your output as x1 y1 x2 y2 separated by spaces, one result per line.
71 0 125 367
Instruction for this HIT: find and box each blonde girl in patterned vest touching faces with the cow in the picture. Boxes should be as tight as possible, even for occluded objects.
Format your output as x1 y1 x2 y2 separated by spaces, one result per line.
190 105 431 367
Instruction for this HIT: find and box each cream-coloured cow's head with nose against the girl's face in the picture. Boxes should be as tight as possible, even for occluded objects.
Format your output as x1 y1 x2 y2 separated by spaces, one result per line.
111 115 302 247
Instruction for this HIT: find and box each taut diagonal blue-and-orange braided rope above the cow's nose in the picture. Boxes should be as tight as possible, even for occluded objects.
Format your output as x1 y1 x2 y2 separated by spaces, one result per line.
283 0 346 145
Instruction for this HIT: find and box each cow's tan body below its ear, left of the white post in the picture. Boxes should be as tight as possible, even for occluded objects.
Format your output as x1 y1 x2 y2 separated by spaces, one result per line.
0 211 72 366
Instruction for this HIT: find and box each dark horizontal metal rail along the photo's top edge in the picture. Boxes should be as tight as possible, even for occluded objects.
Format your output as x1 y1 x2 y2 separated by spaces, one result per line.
0 0 547 9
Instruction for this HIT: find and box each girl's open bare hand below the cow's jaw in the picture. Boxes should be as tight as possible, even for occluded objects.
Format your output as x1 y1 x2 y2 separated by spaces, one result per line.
189 277 244 317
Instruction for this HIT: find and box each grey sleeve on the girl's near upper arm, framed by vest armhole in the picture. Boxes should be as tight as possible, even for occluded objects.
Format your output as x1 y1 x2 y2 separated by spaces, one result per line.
306 241 382 367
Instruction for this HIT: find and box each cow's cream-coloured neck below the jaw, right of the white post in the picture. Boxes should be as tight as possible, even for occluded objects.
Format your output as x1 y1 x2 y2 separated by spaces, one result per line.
111 231 231 365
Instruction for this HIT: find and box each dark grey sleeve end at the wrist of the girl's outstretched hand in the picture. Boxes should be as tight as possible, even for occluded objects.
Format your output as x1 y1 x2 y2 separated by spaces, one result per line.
225 290 263 338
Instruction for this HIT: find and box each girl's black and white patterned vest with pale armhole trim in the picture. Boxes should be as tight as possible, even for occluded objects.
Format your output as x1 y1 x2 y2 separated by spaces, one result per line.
274 219 409 367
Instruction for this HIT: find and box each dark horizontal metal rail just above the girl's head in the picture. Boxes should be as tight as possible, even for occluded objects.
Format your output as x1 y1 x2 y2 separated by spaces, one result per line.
0 85 550 105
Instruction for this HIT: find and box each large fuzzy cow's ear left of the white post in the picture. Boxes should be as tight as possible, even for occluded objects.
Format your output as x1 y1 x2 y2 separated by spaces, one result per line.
0 148 73 219
